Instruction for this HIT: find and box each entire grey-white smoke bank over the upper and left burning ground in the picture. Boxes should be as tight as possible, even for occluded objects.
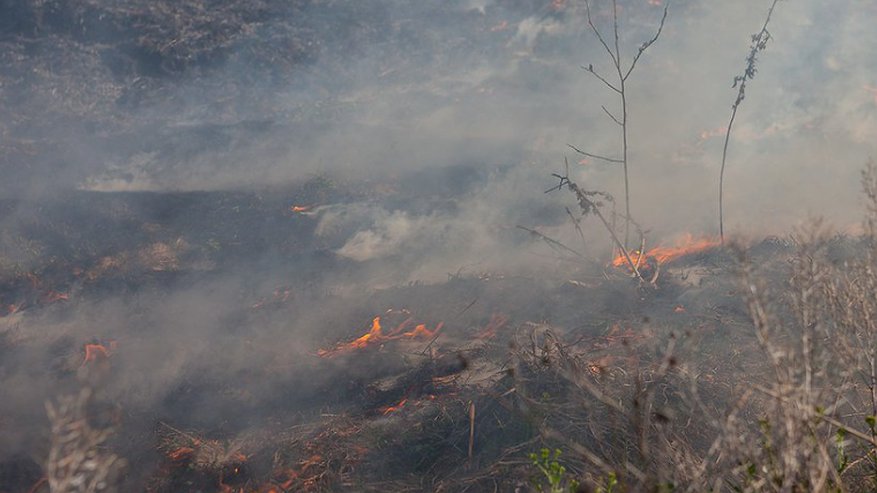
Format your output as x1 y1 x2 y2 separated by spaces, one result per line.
0 0 877 489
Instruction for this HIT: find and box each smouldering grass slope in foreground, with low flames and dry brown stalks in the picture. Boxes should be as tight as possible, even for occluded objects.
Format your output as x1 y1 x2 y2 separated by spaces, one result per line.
3 183 877 493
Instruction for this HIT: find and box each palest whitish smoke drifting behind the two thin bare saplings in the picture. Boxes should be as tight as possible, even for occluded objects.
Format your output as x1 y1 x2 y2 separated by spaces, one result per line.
12 1 875 240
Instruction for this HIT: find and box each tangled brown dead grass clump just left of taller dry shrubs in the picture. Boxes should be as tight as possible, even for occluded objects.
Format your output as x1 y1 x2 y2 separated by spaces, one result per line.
506 322 703 491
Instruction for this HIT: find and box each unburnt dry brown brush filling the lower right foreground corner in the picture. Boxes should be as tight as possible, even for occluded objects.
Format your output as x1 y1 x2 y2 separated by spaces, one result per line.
516 165 877 492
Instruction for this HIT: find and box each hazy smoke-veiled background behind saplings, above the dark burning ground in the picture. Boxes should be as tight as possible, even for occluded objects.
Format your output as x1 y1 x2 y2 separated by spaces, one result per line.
0 0 877 234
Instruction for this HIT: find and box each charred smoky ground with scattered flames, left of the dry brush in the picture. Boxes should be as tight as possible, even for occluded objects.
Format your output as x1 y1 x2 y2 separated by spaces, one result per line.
0 178 808 491
